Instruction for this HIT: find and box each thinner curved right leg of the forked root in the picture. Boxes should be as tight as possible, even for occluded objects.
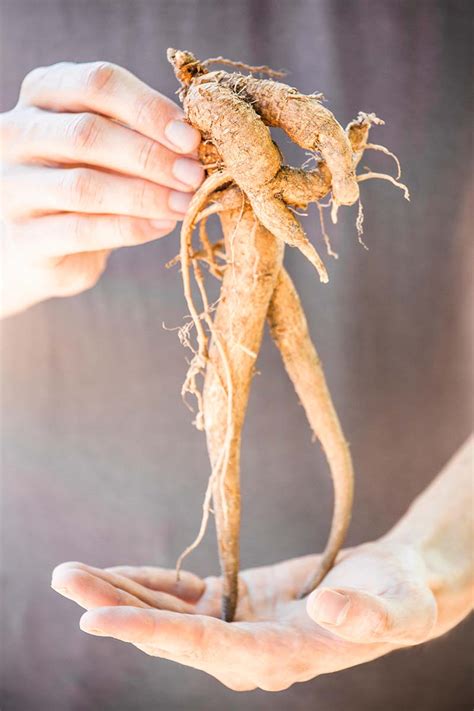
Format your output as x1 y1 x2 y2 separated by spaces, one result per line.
268 268 354 597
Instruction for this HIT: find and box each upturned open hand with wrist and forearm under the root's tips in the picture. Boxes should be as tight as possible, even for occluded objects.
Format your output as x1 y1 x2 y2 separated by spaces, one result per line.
51 438 474 691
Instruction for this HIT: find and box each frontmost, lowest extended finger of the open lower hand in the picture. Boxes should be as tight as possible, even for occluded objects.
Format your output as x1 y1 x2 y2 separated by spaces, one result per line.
80 607 256 673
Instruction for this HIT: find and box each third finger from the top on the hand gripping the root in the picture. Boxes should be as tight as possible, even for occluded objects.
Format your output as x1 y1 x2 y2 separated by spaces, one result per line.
3 166 192 221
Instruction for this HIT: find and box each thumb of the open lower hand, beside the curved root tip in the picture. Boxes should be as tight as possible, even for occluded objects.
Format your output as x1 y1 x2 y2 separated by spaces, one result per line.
306 586 436 645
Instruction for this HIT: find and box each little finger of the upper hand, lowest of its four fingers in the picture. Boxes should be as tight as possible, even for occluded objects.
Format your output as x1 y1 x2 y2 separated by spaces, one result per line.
9 212 176 259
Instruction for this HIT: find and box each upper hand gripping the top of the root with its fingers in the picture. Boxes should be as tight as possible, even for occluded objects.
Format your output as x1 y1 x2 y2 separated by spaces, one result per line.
0 62 204 315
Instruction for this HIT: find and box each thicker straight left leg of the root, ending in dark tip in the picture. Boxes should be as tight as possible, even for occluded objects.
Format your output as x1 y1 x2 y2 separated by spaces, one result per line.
203 206 283 621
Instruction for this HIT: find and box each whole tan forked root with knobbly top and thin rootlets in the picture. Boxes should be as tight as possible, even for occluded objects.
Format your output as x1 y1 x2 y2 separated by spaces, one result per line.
168 50 409 621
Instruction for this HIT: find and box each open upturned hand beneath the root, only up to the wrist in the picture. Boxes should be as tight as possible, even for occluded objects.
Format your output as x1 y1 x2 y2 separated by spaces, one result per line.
52 540 436 691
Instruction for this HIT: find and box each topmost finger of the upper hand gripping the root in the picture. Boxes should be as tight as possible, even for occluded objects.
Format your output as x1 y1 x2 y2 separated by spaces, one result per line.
20 62 201 153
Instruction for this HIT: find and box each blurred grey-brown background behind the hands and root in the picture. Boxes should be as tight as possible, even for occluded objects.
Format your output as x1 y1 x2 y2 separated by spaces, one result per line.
0 0 472 711
